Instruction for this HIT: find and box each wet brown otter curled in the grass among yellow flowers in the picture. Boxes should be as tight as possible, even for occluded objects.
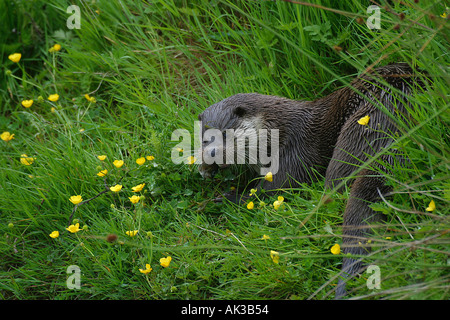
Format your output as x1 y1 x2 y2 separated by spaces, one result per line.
199 63 424 298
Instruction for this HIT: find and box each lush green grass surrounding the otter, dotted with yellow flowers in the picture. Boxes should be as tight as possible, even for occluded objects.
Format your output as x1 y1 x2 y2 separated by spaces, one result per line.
0 0 450 299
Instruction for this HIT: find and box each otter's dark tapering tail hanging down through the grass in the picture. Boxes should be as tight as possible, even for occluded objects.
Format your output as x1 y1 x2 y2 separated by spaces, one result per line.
336 169 390 299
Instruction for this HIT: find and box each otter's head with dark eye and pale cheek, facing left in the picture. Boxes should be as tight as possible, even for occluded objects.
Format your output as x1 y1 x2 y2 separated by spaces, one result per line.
198 94 274 178
